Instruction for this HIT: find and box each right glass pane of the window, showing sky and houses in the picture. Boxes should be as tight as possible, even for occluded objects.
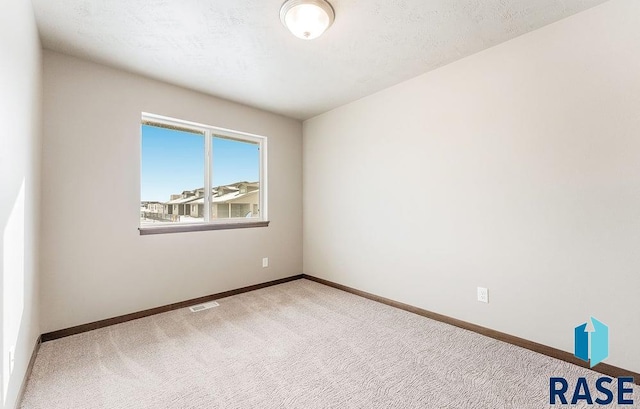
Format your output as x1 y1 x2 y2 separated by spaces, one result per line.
211 136 260 220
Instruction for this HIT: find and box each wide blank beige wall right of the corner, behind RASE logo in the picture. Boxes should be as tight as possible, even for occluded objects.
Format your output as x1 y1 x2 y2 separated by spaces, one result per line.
303 0 640 371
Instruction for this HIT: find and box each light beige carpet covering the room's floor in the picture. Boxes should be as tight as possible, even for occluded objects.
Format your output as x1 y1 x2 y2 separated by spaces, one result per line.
22 280 640 409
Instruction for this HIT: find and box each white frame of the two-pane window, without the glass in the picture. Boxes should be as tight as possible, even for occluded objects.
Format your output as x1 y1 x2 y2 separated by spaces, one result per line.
138 112 269 235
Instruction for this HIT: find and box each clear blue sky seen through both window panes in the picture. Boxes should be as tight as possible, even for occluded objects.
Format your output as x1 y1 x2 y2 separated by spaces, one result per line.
141 125 260 202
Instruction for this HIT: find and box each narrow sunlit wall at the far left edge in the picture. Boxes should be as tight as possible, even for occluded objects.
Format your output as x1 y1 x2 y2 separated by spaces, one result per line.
0 0 42 409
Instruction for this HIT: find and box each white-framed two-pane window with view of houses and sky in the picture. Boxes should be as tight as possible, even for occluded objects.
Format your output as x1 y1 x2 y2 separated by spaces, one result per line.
140 114 268 234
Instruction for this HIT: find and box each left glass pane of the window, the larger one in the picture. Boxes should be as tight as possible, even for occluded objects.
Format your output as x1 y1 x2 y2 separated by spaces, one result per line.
140 125 205 226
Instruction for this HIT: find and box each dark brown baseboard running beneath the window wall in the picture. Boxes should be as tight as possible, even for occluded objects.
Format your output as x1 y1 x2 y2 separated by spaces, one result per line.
42 274 302 342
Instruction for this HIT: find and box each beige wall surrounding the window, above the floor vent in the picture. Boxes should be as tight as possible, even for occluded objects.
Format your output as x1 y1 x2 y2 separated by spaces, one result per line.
41 51 302 332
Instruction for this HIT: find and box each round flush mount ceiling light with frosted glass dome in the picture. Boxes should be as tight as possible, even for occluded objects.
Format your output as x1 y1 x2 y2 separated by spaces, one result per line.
280 0 335 40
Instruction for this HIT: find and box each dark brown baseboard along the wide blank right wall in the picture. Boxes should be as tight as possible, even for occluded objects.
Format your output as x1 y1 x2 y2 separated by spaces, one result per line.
302 274 640 385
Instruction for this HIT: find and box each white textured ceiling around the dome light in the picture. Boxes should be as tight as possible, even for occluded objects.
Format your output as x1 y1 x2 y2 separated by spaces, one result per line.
32 0 605 119
